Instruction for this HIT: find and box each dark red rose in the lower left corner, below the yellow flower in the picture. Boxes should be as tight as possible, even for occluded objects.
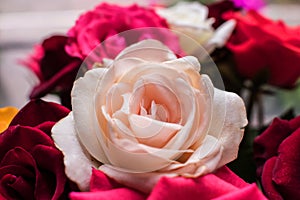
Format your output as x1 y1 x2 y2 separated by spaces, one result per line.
0 100 75 200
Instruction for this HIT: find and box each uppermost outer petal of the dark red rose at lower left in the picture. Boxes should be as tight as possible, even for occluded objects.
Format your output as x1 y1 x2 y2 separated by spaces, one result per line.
10 99 70 126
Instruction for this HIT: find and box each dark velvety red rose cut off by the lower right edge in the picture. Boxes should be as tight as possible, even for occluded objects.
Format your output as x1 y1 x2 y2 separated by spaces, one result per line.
254 116 300 199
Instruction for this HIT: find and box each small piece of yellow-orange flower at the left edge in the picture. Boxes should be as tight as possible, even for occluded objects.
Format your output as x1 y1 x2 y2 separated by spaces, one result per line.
0 106 19 134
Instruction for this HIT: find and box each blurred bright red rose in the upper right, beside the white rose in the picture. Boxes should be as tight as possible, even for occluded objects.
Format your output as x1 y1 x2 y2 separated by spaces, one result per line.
225 11 300 88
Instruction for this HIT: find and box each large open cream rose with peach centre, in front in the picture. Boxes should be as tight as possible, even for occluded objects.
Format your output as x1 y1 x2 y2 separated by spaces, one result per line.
52 40 247 192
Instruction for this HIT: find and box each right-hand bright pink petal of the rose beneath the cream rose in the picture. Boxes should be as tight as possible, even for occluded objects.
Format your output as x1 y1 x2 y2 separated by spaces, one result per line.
148 169 266 200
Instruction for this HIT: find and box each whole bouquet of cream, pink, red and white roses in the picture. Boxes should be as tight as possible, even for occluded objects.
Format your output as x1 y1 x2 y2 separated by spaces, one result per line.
0 1 300 200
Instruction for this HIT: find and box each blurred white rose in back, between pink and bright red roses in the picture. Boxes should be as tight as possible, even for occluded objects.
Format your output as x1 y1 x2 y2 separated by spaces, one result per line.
157 2 236 56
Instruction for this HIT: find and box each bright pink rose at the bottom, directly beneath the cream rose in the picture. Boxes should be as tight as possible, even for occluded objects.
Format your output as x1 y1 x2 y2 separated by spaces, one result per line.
70 167 266 200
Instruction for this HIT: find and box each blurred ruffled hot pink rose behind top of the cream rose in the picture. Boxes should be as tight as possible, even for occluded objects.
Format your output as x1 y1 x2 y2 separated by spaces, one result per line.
66 3 180 63
